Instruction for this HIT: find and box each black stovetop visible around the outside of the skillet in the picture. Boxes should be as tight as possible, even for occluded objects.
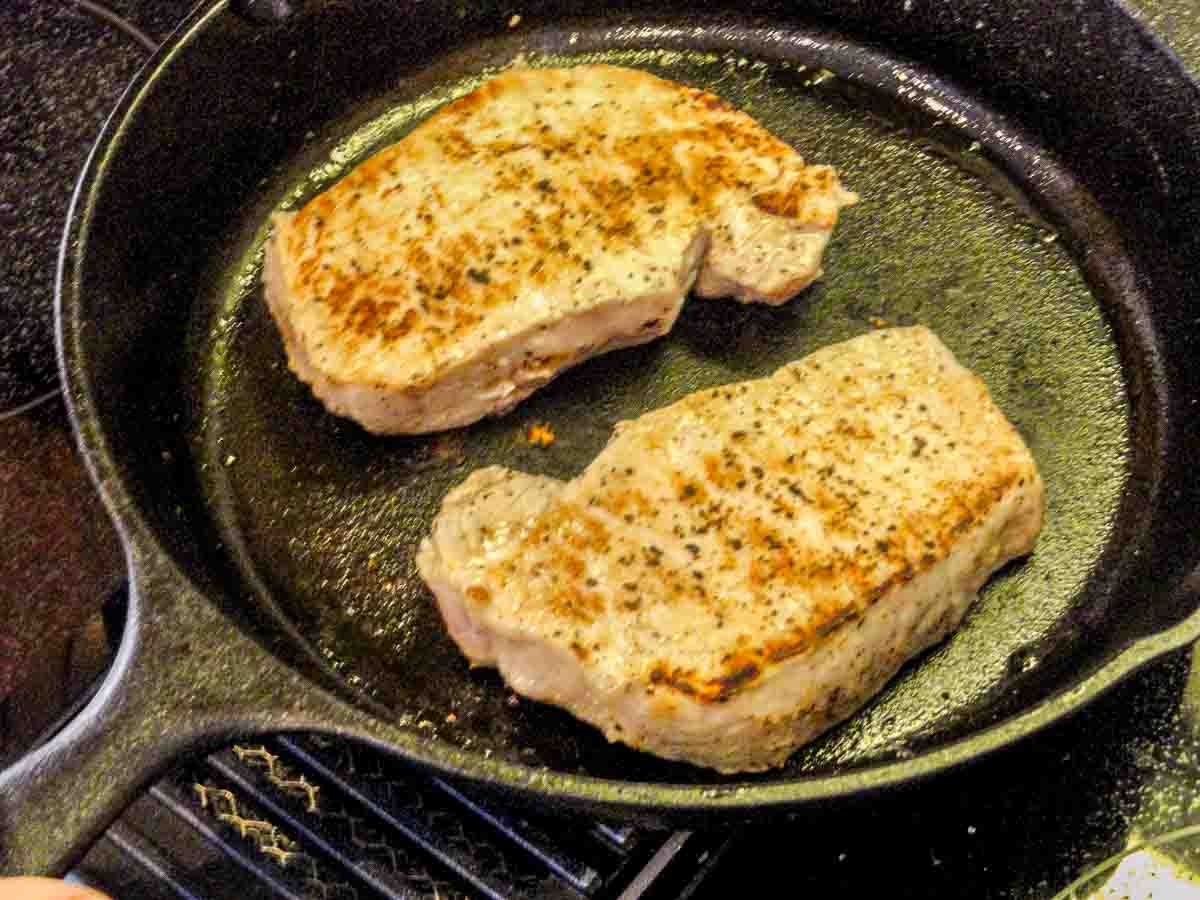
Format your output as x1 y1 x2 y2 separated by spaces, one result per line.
0 0 1200 900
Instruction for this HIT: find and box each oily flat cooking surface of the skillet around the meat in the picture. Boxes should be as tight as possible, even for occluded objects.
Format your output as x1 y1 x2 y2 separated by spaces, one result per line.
194 35 1129 781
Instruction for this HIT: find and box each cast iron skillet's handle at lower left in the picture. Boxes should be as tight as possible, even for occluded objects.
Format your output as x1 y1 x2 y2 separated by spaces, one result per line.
0 562 355 875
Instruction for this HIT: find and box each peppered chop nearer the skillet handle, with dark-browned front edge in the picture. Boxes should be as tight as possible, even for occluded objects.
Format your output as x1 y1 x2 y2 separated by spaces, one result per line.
418 328 1043 772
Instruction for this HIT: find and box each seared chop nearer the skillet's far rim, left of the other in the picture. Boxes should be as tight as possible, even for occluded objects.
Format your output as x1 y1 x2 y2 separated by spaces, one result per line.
264 66 854 433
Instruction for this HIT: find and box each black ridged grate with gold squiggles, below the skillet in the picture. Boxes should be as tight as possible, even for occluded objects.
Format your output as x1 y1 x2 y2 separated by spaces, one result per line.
77 736 732 900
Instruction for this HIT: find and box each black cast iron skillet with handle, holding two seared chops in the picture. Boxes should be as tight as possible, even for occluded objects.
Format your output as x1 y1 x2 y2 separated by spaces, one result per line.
0 0 1200 871
